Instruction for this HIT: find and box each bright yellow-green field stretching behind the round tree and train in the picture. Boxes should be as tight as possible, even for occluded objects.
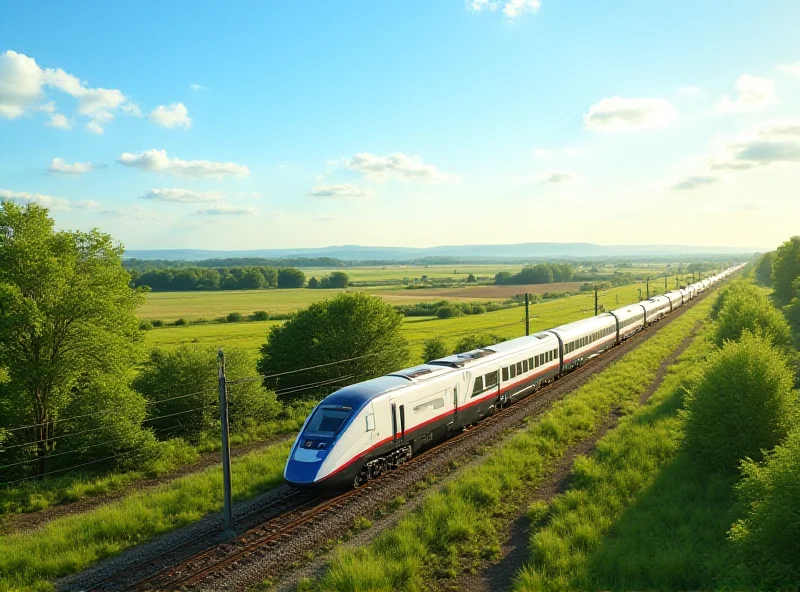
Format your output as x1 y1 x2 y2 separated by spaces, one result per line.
145 278 675 362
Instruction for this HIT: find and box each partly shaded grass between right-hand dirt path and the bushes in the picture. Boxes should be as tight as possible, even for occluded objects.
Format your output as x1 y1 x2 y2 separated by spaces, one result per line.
517 310 720 591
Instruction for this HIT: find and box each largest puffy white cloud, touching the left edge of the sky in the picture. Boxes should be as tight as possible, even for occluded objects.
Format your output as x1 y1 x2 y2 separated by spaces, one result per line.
0 50 138 133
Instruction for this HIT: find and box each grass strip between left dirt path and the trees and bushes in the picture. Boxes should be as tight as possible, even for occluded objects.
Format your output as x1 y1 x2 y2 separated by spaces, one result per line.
0 401 316 518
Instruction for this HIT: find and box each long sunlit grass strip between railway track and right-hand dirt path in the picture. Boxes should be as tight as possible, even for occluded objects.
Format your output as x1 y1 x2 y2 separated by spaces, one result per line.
304 294 710 591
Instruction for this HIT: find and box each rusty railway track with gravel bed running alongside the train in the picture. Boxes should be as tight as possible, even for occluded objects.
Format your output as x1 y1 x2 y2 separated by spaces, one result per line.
81 284 724 590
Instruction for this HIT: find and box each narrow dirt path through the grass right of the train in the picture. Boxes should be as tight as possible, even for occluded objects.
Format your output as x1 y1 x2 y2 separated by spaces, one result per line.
446 321 702 592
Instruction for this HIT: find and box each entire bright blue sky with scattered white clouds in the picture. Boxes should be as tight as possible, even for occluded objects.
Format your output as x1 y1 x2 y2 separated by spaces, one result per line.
0 0 800 250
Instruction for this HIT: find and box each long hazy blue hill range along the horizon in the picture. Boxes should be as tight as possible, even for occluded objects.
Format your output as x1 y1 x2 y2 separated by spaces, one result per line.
125 243 763 262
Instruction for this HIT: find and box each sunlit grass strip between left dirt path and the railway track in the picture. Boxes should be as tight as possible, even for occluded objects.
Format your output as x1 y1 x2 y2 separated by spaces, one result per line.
0 442 291 591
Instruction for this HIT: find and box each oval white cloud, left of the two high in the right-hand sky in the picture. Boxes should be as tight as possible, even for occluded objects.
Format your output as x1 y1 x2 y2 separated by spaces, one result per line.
583 97 678 133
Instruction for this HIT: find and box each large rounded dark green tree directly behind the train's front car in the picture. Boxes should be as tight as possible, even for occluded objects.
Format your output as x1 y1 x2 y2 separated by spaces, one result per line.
258 292 408 401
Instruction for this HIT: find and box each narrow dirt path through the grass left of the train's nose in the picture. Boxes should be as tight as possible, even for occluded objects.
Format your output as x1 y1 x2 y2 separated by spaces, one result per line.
0 434 295 535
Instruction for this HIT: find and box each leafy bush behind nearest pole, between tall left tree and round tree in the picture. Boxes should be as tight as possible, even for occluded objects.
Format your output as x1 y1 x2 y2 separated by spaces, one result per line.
133 345 279 439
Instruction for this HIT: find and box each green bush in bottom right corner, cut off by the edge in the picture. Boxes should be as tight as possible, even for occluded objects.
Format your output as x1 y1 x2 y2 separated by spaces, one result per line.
730 427 800 589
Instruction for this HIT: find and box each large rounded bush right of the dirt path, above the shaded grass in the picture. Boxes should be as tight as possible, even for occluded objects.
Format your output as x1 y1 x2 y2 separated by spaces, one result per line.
685 333 795 471
